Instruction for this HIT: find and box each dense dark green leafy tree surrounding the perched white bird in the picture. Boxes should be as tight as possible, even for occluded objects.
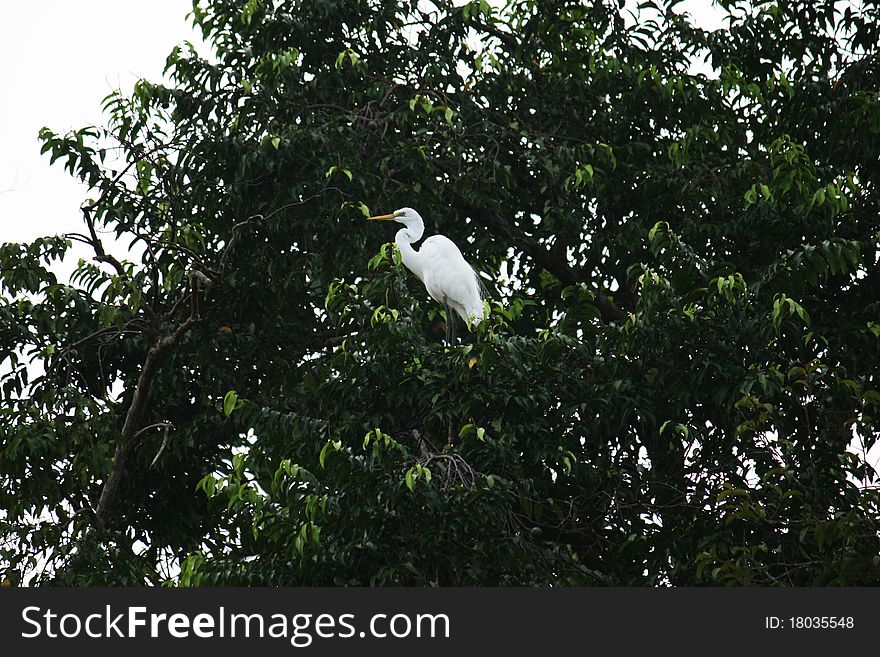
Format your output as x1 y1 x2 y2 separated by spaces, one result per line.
0 0 880 585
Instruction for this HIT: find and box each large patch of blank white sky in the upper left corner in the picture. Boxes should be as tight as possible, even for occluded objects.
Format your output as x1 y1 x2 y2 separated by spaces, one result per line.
0 0 201 243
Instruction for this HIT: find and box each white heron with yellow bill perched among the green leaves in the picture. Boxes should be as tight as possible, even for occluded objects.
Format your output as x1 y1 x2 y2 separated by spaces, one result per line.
369 208 484 345
